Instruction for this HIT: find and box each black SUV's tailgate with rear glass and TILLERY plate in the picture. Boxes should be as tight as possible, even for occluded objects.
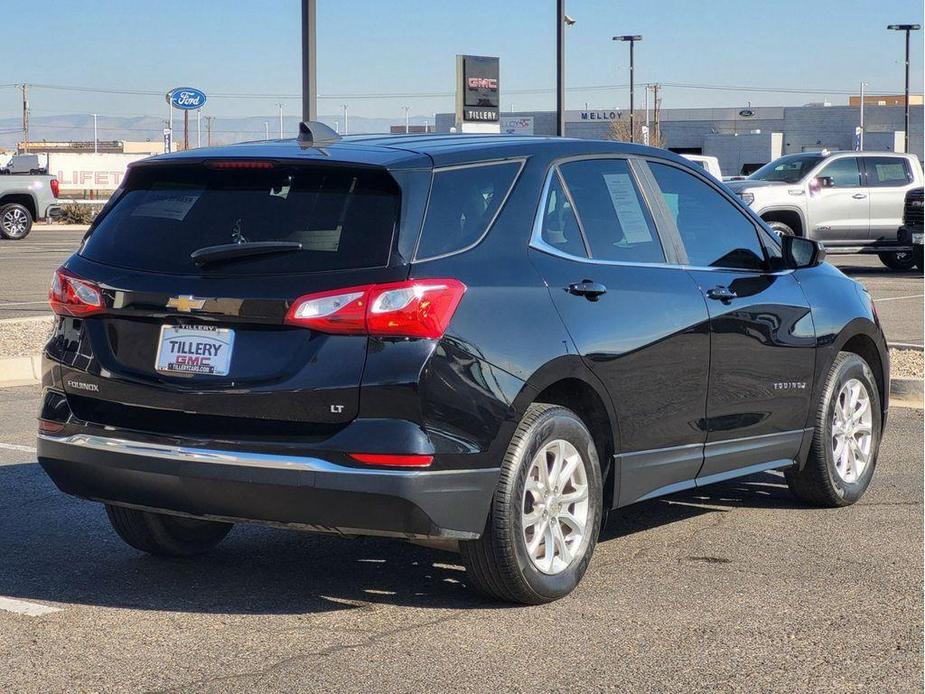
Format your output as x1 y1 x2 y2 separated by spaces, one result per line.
49 164 420 437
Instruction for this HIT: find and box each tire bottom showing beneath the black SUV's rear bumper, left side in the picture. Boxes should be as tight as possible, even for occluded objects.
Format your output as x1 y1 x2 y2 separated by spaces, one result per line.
106 504 233 557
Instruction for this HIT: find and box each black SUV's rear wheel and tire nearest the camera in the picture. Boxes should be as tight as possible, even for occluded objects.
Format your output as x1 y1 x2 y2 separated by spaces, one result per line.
460 403 603 605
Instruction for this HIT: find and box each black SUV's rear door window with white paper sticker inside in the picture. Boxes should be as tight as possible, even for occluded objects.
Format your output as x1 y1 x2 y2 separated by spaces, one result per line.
560 159 665 263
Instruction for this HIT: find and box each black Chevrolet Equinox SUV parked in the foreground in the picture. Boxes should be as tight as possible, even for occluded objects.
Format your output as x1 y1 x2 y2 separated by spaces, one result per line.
38 125 889 603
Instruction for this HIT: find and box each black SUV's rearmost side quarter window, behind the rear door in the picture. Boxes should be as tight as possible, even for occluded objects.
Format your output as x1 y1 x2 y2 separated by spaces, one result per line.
415 161 522 261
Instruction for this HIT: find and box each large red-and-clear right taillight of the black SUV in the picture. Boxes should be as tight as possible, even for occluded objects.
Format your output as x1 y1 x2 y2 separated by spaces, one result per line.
286 279 466 339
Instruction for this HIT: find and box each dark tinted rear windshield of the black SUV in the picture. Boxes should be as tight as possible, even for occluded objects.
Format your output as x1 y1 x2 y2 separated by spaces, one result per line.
81 165 401 275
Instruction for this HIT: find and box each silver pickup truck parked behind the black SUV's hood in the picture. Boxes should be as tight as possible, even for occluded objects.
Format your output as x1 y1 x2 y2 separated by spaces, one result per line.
727 151 922 271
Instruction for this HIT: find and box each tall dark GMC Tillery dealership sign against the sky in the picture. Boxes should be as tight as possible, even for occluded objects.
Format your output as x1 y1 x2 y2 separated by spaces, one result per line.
456 55 501 132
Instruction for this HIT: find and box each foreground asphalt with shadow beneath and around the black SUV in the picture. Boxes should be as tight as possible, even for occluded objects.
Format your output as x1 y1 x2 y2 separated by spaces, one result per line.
0 386 923 692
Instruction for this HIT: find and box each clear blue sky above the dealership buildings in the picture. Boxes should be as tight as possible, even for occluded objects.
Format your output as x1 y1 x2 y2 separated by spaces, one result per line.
0 0 923 120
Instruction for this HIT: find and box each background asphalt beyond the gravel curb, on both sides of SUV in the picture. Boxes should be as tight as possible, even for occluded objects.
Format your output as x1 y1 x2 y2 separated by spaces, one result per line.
0 229 923 345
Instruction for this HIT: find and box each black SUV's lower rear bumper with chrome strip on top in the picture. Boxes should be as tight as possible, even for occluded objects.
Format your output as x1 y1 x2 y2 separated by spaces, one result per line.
38 434 499 539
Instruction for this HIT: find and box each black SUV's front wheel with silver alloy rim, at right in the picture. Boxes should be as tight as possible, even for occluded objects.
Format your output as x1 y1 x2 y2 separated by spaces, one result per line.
785 352 883 508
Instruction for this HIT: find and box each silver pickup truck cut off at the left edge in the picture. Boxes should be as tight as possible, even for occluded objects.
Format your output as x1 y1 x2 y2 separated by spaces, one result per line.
0 174 62 240
